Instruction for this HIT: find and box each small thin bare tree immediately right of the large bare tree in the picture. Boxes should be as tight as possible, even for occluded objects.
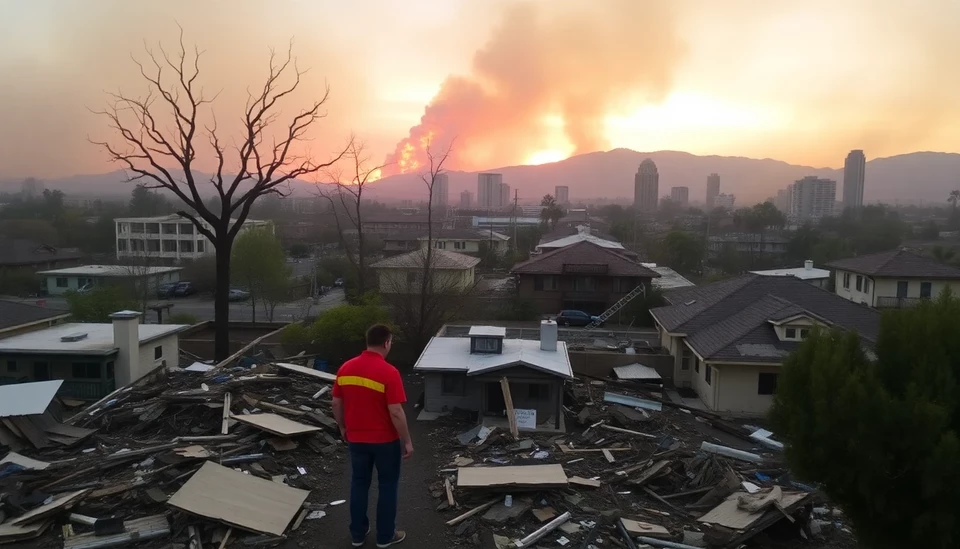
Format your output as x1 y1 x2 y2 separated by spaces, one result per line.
319 140 386 295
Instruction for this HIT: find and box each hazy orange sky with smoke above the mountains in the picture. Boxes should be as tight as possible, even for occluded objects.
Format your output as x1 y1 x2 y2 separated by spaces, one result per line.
0 0 960 177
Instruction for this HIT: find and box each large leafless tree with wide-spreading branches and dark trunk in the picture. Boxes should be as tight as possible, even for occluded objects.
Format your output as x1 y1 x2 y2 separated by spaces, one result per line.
94 29 346 360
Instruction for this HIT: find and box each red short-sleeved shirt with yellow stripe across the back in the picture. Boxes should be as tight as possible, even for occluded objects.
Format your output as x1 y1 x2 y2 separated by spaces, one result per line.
333 351 407 444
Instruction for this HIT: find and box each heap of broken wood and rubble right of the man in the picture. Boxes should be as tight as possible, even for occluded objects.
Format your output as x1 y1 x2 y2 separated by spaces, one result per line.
429 380 852 549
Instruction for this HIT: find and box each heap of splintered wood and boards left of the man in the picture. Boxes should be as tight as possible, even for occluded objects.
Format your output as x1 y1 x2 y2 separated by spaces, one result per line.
0 363 344 549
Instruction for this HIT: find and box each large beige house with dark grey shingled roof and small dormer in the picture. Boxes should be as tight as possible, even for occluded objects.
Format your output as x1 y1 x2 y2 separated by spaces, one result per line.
650 274 880 415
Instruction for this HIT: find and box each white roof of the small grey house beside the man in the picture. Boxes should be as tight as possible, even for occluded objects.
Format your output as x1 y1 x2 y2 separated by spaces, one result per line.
413 337 573 378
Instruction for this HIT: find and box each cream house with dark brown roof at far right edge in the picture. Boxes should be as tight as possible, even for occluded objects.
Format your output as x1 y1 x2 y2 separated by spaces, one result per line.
827 249 960 309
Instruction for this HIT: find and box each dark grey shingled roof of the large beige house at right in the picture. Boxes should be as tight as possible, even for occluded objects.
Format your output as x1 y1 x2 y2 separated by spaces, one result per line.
651 274 880 362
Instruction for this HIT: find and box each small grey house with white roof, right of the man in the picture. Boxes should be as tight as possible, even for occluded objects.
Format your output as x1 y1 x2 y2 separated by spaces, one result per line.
414 320 573 429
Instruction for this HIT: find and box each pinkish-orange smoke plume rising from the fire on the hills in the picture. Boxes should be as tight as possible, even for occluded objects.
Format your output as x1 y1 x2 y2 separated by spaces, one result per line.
384 0 684 175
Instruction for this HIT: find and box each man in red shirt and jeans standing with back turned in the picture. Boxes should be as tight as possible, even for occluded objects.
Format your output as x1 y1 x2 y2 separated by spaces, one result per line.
333 324 413 547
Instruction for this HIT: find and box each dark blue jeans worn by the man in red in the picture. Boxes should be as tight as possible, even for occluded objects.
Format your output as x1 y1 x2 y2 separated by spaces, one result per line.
350 440 403 543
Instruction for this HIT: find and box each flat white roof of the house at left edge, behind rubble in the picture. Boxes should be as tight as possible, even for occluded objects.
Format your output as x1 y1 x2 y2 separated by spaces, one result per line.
0 323 189 355
